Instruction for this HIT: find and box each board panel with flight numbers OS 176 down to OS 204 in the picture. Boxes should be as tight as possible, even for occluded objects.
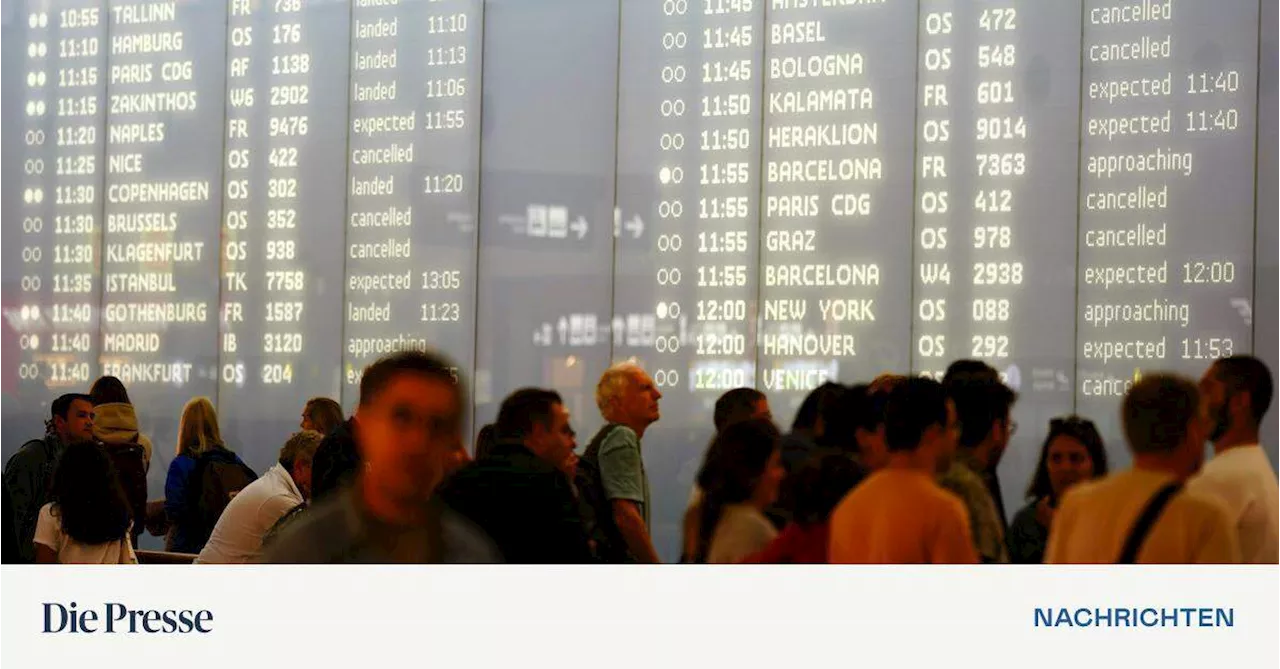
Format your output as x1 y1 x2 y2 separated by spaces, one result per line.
218 0 350 444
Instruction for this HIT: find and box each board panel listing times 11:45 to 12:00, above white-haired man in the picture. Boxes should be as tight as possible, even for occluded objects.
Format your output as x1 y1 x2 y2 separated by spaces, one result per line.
613 3 768 565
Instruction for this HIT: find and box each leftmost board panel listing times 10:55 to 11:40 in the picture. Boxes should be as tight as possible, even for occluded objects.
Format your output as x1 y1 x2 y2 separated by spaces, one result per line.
0 0 109 432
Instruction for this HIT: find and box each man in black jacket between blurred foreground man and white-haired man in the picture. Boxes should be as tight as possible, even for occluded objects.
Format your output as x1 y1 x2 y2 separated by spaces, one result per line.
440 388 591 564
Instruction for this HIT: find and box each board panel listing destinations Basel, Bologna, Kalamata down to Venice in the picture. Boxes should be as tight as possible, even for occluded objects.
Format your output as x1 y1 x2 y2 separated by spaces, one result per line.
758 0 918 416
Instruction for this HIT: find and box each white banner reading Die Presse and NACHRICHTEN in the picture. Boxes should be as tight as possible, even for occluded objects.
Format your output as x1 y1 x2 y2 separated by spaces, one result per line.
0 565 1280 669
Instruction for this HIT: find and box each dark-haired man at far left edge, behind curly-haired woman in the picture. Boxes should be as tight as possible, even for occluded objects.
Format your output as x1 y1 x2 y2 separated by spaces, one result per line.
4 393 93 563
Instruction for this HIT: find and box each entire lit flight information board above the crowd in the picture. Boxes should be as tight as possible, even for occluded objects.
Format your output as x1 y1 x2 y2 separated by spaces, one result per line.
0 0 1280 554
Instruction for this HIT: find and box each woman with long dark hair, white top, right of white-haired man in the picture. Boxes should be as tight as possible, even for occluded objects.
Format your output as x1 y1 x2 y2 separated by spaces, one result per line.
692 418 786 564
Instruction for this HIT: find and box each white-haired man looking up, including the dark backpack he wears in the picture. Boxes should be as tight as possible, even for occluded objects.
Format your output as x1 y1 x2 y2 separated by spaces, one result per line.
579 363 662 564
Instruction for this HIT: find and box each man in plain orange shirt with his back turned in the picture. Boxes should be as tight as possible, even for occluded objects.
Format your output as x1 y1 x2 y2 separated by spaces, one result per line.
828 379 978 564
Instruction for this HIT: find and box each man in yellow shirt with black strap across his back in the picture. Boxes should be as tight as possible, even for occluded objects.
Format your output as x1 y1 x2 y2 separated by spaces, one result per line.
1044 375 1240 564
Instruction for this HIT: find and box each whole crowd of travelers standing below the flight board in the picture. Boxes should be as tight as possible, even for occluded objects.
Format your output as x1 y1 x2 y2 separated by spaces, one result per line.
0 352 1280 564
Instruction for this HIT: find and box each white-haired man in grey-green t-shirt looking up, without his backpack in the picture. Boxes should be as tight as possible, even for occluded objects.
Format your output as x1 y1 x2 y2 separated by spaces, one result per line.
595 363 662 563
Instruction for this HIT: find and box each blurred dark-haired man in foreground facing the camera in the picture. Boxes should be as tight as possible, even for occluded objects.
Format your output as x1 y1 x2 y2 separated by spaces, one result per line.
266 352 500 564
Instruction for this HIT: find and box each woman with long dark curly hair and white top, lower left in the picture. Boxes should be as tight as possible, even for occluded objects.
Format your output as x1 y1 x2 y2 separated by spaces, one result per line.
36 441 138 564
